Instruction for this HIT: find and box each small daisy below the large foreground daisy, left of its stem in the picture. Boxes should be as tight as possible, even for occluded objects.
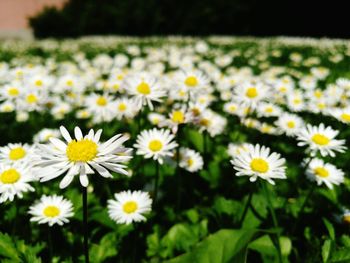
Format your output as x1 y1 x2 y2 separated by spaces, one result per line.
28 195 74 227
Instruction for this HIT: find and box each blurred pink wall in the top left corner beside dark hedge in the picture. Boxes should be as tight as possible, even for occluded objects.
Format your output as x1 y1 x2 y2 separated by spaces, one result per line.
0 0 66 30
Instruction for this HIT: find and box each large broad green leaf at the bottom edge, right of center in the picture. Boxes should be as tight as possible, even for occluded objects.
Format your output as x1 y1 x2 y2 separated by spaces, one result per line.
166 229 256 263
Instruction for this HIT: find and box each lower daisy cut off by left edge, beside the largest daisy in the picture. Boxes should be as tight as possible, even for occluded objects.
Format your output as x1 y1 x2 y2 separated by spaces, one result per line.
0 164 36 203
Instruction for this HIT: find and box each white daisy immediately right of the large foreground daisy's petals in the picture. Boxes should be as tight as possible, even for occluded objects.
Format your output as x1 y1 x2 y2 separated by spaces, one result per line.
134 128 178 164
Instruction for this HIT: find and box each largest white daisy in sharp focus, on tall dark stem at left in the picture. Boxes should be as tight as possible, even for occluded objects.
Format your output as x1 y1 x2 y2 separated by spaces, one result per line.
36 126 131 188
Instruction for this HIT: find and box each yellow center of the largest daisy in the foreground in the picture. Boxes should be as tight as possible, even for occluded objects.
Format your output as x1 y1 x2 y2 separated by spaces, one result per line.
66 139 97 162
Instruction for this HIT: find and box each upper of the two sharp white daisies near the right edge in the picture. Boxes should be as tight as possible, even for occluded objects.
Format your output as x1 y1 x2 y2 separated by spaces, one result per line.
297 123 346 157
